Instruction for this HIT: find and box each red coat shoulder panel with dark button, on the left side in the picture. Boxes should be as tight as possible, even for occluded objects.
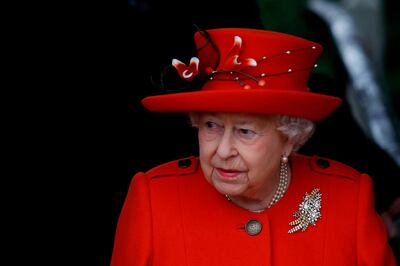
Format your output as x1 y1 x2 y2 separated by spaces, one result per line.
146 156 199 179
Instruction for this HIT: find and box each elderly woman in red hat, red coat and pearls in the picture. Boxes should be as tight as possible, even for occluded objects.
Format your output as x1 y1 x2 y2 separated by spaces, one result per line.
111 28 395 266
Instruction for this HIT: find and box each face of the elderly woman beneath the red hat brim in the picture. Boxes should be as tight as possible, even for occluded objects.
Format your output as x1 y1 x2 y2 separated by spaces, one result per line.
195 113 292 199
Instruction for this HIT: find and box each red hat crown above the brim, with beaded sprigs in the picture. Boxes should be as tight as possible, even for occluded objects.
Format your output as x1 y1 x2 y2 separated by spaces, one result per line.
194 28 322 91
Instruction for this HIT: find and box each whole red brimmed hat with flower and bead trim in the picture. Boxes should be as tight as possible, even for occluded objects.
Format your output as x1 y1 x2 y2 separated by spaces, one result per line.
142 28 342 121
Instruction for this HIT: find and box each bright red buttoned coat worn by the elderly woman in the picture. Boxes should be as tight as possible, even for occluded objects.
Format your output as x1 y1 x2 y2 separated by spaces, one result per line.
111 155 395 266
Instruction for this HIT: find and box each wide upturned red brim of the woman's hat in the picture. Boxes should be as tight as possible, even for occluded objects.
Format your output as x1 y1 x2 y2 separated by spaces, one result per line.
142 89 342 121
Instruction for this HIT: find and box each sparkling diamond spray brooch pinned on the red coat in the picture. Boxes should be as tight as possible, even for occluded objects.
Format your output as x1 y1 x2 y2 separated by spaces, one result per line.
288 188 322 234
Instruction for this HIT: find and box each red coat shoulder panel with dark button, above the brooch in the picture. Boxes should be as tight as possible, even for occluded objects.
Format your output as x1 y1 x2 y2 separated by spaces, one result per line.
301 155 361 181
